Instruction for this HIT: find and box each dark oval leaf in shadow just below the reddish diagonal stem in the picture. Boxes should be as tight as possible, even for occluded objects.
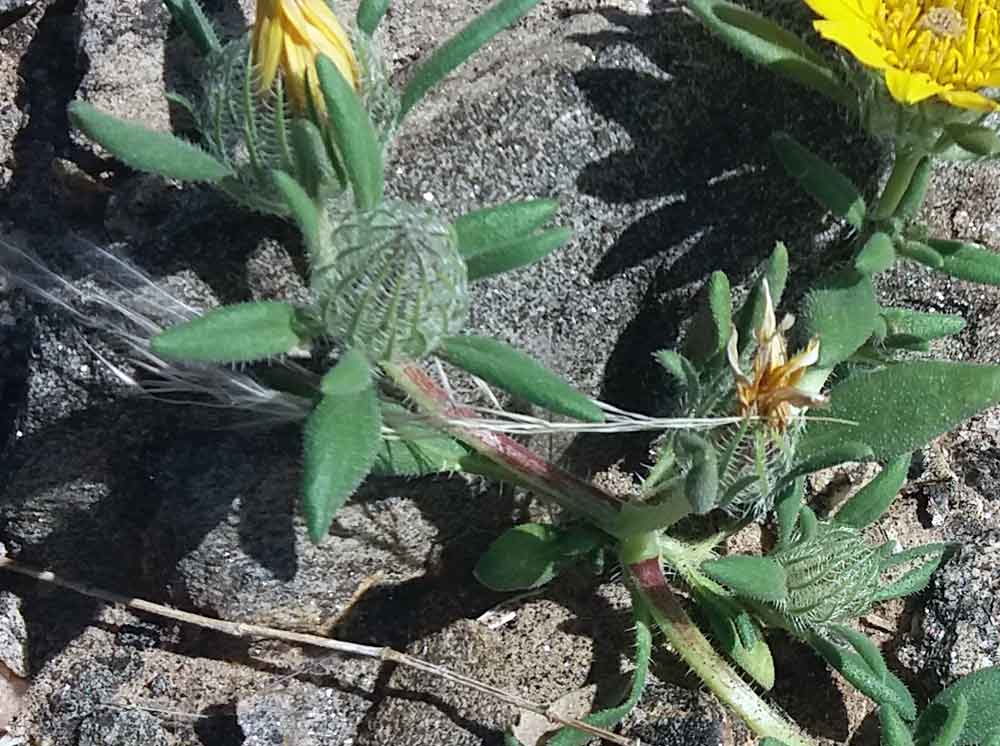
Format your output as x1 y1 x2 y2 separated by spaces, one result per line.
473 523 562 591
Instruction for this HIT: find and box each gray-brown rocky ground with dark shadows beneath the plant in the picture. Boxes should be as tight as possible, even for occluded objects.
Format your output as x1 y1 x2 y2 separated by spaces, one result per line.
0 0 1000 746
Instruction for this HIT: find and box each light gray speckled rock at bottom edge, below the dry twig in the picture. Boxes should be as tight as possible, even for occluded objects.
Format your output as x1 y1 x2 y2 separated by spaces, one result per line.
236 682 370 746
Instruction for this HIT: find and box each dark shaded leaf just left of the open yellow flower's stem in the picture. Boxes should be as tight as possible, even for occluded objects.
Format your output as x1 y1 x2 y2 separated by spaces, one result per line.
771 132 868 228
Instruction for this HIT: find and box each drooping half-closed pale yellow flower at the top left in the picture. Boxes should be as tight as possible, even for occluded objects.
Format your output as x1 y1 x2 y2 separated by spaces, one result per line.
252 0 360 112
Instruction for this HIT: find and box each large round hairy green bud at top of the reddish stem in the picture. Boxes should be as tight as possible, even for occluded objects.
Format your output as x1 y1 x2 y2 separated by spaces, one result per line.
312 201 469 361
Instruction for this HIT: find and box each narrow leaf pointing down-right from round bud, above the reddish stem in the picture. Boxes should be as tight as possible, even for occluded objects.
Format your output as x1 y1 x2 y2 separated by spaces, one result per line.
436 334 604 422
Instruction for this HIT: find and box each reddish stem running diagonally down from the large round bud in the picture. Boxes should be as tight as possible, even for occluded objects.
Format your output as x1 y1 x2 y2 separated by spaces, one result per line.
382 363 623 536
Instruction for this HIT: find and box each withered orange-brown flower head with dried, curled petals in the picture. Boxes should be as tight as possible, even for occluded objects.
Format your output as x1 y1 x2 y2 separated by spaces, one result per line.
726 280 827 432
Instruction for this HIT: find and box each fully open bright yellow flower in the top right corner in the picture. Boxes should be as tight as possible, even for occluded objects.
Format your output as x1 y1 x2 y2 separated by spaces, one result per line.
806 0 1000 111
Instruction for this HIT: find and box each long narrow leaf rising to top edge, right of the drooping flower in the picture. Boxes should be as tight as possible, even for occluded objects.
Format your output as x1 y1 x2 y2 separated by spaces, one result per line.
399 0 539 119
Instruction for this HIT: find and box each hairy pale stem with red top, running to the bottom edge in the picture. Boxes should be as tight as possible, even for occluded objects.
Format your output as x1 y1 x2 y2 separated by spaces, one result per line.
627 558 816 746
